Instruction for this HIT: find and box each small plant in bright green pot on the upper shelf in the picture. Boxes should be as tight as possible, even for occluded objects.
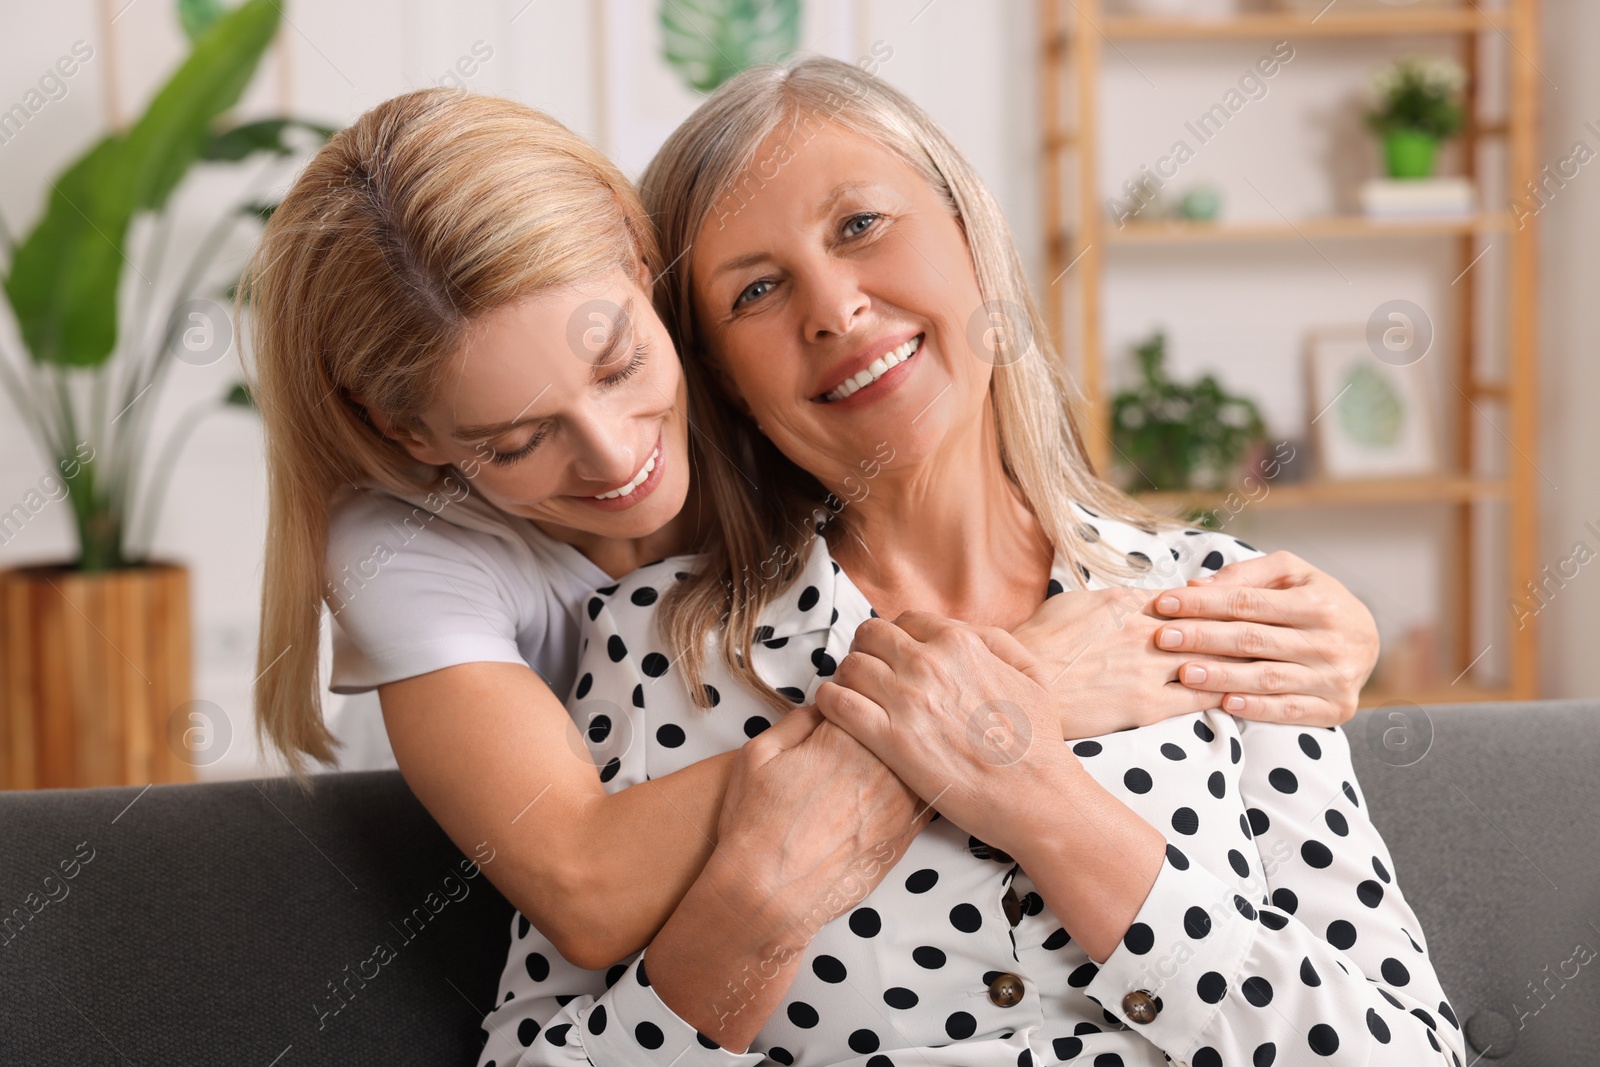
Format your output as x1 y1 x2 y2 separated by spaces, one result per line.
1366 56 1467 178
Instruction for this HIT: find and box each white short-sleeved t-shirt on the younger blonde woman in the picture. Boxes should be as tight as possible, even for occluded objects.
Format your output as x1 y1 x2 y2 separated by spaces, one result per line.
326 478 611 769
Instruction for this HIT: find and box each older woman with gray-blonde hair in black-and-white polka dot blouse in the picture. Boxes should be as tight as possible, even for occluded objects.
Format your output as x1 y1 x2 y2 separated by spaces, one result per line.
483 59 1462 1067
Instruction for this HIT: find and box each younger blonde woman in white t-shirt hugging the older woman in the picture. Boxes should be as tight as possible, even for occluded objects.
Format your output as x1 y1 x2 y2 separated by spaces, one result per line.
246 90 1376 966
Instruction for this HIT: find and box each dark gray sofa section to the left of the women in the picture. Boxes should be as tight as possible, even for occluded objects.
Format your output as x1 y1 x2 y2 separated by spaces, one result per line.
0 771 512 1067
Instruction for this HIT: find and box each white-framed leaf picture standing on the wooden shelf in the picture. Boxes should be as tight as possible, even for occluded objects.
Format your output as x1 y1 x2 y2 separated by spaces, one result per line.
1306 326 1438 478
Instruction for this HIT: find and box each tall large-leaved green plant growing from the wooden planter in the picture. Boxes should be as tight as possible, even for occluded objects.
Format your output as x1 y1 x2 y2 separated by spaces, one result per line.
0 0 333 571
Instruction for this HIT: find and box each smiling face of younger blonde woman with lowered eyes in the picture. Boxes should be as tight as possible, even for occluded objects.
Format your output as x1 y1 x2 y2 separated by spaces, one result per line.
397 262 690 537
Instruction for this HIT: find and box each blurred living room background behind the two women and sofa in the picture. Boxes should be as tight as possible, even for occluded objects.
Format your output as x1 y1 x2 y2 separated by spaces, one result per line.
0 0 1600 787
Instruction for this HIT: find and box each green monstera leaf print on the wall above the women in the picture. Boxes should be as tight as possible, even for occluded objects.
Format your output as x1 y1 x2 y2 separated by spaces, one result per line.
661 0 800 93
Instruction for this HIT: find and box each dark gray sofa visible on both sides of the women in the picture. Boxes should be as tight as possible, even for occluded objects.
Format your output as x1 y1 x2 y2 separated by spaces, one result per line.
0 701 1600 1067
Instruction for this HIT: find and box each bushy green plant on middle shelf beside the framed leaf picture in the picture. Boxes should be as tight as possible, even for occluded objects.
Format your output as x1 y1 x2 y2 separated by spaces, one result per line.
1110 330 1267 493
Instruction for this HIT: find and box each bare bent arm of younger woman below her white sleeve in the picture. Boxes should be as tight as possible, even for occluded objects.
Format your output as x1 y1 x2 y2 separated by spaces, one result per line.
378 662 738 968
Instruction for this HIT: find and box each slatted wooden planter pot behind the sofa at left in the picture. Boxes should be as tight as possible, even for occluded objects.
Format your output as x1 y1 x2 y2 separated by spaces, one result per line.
0 563 194 789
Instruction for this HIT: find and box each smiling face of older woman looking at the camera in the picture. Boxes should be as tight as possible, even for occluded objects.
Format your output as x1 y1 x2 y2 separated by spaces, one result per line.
690 123 992 488
